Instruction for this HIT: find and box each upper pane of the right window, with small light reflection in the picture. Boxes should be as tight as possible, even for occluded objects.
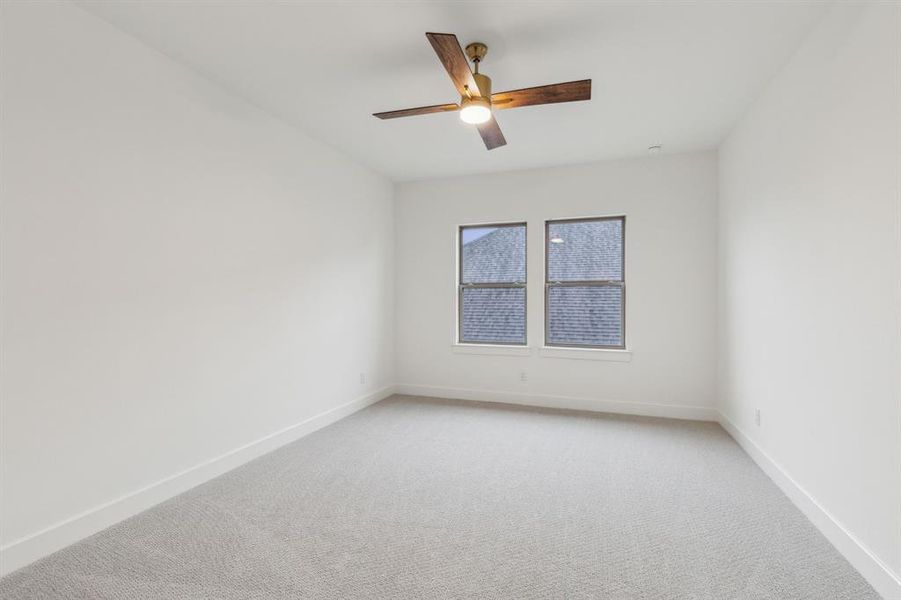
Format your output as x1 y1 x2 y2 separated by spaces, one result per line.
547 219 623 281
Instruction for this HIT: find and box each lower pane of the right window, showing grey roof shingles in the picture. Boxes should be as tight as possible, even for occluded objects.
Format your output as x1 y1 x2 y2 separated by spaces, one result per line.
547 286 623 346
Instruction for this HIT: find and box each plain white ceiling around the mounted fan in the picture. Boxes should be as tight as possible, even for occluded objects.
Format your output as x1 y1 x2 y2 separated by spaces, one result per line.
78 0 825 181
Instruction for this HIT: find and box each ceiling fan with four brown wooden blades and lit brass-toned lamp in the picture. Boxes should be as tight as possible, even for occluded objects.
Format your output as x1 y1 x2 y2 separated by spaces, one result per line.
373 33 591 150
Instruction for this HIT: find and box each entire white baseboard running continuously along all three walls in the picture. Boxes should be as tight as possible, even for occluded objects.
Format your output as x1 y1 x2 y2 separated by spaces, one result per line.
7 384 901 600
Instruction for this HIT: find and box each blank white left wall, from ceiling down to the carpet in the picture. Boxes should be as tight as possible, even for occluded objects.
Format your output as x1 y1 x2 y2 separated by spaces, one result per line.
0 2 394 570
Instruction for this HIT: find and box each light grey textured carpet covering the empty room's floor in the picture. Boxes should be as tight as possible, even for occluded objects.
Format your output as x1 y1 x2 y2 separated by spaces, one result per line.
0 396 879 600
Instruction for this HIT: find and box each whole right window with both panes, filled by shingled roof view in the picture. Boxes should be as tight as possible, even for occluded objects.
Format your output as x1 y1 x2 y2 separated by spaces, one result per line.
544 217 626 348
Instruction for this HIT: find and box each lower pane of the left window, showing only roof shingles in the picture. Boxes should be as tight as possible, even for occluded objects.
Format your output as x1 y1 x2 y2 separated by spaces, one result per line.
460 288 526 344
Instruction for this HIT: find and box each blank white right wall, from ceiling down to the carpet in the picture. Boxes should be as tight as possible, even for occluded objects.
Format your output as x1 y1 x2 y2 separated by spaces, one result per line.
719 3 901 598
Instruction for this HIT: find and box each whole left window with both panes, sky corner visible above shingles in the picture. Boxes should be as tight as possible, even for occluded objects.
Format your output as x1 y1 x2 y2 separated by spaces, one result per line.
457 223 526 346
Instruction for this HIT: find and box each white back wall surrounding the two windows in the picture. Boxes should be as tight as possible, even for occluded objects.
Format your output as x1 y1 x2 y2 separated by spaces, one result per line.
395 150 716 418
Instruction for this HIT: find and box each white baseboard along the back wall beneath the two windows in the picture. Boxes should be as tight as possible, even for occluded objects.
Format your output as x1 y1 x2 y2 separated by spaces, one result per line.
395 383 718 421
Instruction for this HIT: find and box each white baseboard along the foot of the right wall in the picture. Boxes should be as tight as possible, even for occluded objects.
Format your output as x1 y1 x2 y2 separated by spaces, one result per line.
719 413 901 600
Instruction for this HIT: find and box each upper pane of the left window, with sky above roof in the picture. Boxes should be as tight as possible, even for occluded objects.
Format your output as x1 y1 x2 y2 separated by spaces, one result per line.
460 225 526 283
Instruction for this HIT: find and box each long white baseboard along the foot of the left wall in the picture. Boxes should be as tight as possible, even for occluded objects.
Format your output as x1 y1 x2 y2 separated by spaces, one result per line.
0 386 395 576
